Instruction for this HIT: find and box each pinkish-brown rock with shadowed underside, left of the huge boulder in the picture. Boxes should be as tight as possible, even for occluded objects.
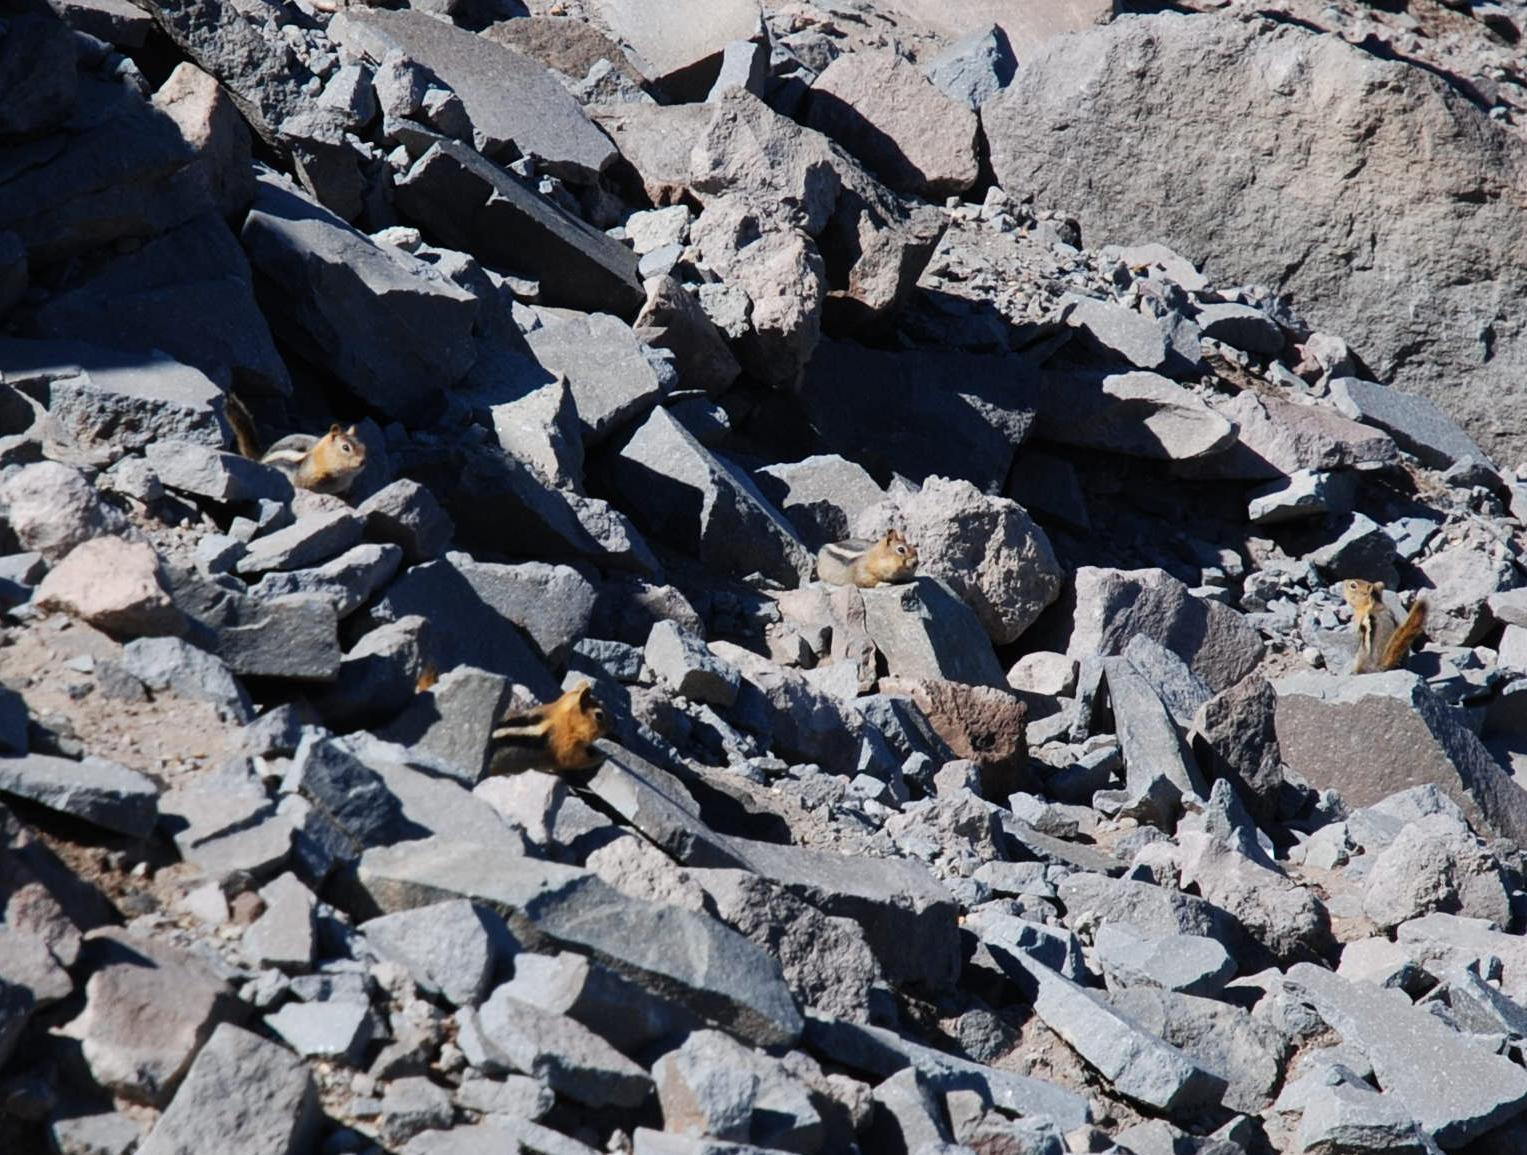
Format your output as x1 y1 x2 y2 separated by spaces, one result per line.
806 49 979 200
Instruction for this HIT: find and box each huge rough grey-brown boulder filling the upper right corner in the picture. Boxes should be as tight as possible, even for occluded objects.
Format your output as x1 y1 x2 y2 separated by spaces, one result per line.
982 14 1527 460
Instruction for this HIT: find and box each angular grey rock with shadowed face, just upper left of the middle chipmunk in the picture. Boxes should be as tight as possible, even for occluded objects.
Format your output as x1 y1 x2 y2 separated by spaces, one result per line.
608 408 812 587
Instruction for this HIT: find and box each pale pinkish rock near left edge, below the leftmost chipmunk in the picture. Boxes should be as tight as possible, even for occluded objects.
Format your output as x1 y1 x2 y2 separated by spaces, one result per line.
34 538 185 637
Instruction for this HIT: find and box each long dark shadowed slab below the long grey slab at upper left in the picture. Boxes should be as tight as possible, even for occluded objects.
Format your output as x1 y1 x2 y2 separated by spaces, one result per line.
397 141 646 316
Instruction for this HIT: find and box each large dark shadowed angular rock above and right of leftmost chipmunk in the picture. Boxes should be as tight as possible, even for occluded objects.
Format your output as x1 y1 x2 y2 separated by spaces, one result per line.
241 173 478 422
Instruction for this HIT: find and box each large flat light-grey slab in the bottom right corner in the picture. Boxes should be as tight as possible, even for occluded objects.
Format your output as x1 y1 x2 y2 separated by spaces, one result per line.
1287 963 1527 1147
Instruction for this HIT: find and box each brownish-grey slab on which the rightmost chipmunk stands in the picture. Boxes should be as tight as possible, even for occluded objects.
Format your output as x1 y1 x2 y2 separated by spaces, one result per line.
1274 669 1527 839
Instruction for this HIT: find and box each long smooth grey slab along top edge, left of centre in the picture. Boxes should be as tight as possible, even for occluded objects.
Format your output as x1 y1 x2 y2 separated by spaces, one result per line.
328 9 615 185
